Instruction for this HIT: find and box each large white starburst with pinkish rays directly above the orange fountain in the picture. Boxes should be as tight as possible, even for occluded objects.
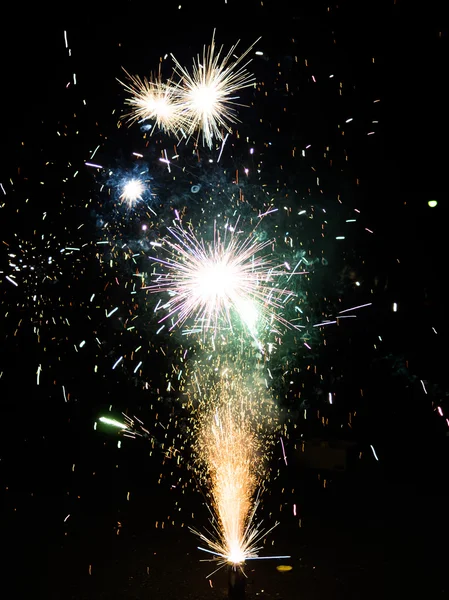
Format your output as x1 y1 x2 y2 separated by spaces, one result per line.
144 223 292 339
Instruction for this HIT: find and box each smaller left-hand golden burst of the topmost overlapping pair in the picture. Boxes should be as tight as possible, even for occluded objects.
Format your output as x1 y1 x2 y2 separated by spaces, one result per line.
118 71 186 135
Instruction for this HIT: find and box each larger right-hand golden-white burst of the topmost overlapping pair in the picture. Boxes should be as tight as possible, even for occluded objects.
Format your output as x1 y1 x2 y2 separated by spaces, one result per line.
172 32 260 148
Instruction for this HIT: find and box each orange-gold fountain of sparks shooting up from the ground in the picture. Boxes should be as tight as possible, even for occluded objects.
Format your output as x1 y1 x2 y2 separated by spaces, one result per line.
188 372 288 572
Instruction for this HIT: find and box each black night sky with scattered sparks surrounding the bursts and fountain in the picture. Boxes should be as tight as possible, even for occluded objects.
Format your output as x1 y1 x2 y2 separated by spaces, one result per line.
0 0 449 600
